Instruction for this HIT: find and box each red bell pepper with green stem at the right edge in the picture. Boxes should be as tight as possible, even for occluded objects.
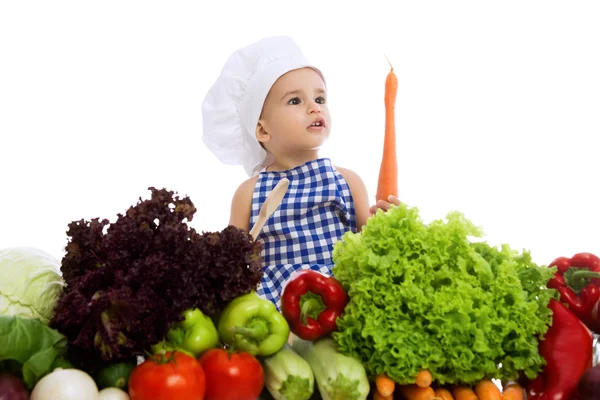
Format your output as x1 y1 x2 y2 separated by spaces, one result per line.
548 253 600 333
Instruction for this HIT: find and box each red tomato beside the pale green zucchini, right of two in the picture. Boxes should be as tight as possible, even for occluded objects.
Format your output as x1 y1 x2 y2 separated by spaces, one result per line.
200 349 265 400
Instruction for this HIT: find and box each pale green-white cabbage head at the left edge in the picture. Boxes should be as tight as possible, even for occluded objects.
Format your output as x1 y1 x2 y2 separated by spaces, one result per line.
0 247 63 324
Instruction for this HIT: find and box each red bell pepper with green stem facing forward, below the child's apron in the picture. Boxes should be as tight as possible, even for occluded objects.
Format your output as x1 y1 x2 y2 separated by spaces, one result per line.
281 270 348 340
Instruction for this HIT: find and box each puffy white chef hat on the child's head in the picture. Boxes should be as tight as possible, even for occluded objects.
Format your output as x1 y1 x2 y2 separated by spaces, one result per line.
202 36 323 176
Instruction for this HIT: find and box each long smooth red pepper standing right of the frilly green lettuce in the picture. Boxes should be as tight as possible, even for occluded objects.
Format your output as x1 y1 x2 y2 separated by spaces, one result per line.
526 299 593 400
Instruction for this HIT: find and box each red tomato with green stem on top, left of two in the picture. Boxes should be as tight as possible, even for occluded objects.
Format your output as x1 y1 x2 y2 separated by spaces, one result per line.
129 351 206 400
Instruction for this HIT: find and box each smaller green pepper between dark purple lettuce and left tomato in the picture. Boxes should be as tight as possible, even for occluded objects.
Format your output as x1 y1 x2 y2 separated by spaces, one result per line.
152 308 219 357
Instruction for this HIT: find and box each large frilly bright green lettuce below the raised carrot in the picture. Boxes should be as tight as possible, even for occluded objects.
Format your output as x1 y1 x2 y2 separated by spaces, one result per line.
333 205 556 384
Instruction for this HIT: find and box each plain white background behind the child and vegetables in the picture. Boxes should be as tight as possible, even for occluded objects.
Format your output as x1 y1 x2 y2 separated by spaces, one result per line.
0 0 600 264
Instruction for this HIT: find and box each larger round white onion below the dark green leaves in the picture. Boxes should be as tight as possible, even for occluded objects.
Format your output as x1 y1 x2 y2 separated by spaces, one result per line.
30 368 99 400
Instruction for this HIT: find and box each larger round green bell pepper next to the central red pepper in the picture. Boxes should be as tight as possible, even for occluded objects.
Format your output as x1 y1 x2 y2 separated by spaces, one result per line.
219 292 290 356
